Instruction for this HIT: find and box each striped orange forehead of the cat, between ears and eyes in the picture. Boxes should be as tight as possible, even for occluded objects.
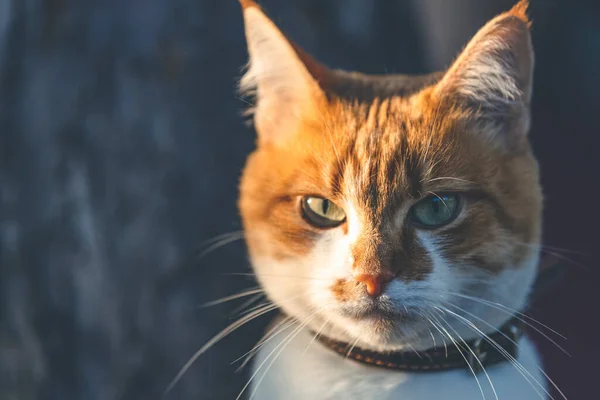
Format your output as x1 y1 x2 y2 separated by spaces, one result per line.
272 89 502 219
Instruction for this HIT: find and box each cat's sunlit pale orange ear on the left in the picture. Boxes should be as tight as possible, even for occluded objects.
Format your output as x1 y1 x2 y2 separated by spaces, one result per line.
240 0 326 144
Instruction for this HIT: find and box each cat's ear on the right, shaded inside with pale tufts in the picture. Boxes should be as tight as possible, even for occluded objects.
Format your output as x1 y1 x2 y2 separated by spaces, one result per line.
434 0 534 132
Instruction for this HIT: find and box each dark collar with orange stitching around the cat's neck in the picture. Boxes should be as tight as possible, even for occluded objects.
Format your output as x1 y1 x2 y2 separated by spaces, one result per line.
318 317 523 373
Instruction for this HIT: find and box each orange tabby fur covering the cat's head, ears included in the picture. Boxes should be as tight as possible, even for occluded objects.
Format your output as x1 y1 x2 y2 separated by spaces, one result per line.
239 0 542 301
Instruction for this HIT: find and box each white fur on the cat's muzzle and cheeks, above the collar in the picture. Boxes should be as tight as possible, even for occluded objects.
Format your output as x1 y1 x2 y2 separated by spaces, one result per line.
252 208 539 350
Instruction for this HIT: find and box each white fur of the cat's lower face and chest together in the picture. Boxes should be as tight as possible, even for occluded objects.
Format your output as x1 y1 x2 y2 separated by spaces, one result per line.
246 217 546 400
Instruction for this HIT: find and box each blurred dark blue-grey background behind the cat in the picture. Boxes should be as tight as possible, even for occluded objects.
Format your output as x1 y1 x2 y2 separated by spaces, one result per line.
0 0 600 400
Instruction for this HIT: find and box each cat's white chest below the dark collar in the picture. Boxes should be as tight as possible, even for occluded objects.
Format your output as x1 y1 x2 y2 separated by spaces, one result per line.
249 331 548 400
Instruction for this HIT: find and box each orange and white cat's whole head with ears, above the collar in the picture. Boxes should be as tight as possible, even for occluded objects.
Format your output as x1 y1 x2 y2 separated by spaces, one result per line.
239 0 542 349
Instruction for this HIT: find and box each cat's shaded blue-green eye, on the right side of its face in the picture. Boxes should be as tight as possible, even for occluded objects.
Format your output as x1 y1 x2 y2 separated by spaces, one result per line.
410 194 460 229
